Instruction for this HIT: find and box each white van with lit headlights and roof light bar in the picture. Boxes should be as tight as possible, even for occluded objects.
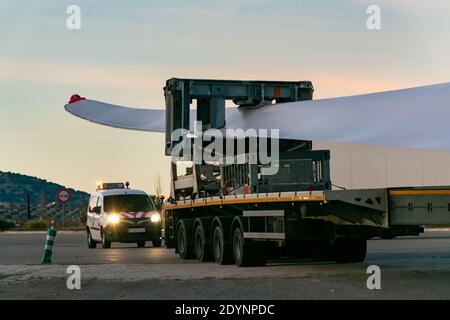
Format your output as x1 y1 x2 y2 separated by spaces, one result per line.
86 182 161 248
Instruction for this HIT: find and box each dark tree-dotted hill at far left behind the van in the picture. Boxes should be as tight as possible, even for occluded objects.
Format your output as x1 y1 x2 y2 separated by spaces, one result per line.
0 171 89 220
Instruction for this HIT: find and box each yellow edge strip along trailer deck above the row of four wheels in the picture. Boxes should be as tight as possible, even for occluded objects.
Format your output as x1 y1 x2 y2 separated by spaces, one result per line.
164 196 325 210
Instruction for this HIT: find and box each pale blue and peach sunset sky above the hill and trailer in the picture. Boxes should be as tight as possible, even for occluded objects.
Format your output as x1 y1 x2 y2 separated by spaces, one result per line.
0 0 450 194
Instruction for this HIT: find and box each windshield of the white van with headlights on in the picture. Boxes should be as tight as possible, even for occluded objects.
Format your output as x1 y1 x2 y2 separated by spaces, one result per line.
103 194 155 213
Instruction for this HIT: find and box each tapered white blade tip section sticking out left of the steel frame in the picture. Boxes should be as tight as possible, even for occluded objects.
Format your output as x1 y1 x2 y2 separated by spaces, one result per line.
64 99 166 132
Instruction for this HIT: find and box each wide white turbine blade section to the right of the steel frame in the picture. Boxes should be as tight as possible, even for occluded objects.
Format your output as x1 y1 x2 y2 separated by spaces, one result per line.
227 83 450 151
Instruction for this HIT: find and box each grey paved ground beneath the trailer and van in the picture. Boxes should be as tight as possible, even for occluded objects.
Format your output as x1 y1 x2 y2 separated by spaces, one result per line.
0 232 450 299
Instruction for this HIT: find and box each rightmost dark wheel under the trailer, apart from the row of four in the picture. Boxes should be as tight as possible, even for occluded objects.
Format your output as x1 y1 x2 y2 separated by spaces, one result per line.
335 237 367 263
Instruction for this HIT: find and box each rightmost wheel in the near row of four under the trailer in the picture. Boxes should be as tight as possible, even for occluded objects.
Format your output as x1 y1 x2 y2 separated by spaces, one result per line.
233 227 267 267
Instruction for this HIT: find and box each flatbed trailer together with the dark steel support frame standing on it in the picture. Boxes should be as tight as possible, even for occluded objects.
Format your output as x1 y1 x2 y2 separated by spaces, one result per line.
159 78 450 266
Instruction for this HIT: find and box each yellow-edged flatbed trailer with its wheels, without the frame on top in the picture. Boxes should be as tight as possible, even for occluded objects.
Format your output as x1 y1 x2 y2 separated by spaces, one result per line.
163 187 450 266
